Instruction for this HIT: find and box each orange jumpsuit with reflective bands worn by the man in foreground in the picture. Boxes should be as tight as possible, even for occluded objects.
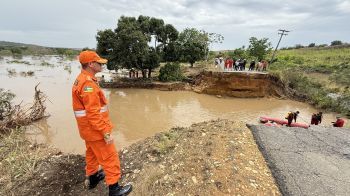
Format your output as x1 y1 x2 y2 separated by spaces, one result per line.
72 69 121 185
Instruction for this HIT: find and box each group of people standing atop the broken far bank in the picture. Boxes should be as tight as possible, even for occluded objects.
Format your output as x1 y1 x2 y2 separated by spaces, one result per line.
215 57 268 71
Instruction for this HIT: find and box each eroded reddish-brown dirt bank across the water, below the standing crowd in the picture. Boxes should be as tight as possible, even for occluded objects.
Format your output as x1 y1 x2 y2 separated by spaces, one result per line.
101 71 284 98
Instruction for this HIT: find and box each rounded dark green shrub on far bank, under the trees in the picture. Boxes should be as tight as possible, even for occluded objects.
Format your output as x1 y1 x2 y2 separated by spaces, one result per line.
158 63 184 82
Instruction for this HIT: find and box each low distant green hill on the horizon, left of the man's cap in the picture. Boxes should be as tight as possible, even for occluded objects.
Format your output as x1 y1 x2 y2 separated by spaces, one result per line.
0 41 80 56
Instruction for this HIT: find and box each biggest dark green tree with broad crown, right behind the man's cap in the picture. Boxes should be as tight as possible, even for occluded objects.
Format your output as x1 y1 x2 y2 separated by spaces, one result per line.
96 15 174 77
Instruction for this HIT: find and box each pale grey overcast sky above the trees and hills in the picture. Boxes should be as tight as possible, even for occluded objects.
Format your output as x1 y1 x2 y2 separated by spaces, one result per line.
0 0 350 50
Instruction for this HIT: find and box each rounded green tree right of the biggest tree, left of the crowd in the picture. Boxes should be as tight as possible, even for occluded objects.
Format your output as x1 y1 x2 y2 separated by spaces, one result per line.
178 28 208 67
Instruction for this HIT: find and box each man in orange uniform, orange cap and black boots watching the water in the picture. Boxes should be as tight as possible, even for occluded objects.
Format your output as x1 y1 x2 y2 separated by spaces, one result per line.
72 50 132 196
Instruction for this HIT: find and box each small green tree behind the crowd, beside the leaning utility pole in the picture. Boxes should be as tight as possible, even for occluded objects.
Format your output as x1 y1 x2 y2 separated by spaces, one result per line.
247 37 272 61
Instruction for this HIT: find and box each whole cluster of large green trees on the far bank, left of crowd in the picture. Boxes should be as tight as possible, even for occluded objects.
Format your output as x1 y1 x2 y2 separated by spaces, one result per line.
96 15 223 78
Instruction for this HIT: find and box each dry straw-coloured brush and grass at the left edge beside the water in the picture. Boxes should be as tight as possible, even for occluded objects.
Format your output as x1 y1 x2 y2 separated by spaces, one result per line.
0 85 52 193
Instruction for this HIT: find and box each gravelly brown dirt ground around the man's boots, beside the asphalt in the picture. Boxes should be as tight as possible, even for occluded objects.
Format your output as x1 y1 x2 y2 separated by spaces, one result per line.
7 120 280 195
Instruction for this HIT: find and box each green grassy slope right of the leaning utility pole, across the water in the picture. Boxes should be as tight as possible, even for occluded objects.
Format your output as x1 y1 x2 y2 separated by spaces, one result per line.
270 47 350 116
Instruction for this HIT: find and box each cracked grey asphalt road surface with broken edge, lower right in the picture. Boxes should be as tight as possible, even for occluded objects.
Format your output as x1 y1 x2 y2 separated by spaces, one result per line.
247 125 350 196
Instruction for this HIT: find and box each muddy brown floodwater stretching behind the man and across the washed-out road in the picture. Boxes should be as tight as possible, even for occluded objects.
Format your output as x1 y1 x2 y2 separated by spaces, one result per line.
0 56 342 153
